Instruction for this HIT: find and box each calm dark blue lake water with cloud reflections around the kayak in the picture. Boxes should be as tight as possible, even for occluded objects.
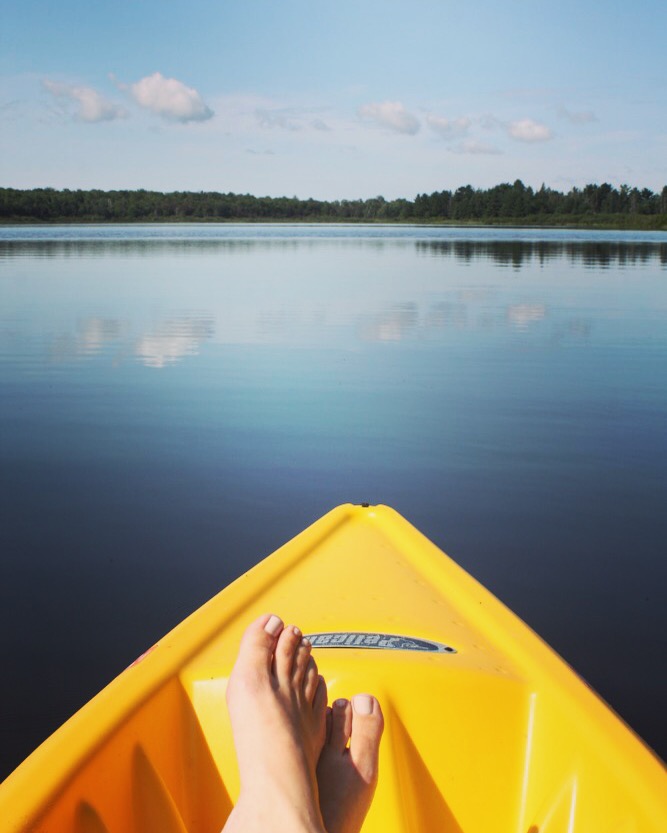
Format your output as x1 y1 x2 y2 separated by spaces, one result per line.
0 225 667 776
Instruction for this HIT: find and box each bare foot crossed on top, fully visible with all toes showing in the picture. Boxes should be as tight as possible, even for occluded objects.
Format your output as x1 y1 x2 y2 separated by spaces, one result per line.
224 614 327 833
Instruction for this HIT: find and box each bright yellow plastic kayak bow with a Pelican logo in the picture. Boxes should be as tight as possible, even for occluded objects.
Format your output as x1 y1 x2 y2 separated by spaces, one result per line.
0 505 667 833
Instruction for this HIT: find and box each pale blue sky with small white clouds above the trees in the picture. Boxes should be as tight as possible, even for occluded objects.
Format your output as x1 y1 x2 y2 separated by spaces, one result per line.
0 0 667 199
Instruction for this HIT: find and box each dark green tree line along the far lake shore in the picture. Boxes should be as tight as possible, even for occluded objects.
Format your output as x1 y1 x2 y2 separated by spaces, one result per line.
0 179 667 229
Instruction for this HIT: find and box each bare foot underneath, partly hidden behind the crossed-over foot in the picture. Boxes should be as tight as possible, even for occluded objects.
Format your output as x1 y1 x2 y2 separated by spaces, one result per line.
317 694 384 833
